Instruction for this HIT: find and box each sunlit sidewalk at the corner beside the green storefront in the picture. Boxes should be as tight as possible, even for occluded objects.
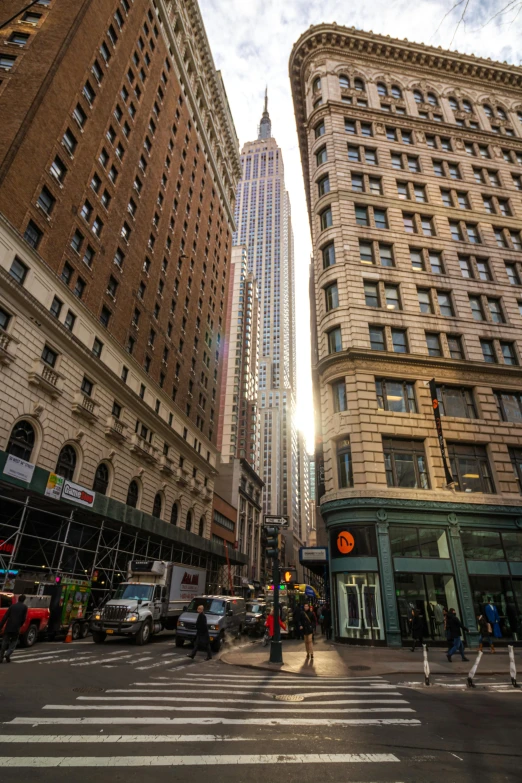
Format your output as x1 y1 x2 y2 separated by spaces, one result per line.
221 636 522 681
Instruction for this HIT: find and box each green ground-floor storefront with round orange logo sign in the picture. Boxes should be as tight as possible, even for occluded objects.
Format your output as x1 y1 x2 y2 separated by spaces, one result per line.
321 498 522 647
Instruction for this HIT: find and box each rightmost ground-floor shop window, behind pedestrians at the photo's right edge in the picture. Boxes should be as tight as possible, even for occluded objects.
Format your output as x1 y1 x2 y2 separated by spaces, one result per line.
469 576 522 641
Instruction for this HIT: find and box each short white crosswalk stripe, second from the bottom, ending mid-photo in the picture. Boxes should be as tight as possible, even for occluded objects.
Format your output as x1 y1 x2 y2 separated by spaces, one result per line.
0 734 250 745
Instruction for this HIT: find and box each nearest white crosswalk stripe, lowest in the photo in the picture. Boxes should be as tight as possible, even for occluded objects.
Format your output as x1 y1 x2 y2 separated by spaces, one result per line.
0 753 399 768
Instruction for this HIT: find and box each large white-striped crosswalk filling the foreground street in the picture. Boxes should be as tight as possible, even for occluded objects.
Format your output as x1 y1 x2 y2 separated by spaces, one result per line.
0 662 421 781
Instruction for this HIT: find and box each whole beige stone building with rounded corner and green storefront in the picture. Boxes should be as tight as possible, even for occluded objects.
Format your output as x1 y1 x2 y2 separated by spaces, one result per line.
290 24 522 644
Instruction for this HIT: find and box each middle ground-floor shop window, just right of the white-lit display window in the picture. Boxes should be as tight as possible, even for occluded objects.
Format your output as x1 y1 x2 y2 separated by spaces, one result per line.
395 573 459 641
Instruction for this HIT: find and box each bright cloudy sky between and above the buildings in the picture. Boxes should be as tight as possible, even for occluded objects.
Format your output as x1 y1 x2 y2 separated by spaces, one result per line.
199 0 522 451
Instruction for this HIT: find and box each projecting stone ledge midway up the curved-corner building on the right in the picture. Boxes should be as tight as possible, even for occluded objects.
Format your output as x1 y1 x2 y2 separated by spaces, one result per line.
313 348 522 383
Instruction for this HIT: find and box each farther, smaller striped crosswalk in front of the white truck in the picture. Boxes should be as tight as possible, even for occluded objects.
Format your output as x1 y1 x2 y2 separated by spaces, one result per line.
11 640 188 671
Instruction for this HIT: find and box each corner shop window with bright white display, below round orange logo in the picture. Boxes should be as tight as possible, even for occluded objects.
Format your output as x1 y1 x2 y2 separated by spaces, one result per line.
336 573 384 640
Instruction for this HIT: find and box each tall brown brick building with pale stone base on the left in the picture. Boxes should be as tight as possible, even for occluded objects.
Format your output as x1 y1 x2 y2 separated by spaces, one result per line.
0 0 246 600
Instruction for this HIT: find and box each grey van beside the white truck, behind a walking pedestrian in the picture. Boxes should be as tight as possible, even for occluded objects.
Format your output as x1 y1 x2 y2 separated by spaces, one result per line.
176 595 246 652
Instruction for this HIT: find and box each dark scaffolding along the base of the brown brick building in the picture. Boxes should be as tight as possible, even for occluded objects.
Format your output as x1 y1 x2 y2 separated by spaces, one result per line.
0 492 233 608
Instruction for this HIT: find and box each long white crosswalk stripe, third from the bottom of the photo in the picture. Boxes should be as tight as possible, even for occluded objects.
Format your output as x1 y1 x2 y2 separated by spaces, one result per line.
4 708 421 726
